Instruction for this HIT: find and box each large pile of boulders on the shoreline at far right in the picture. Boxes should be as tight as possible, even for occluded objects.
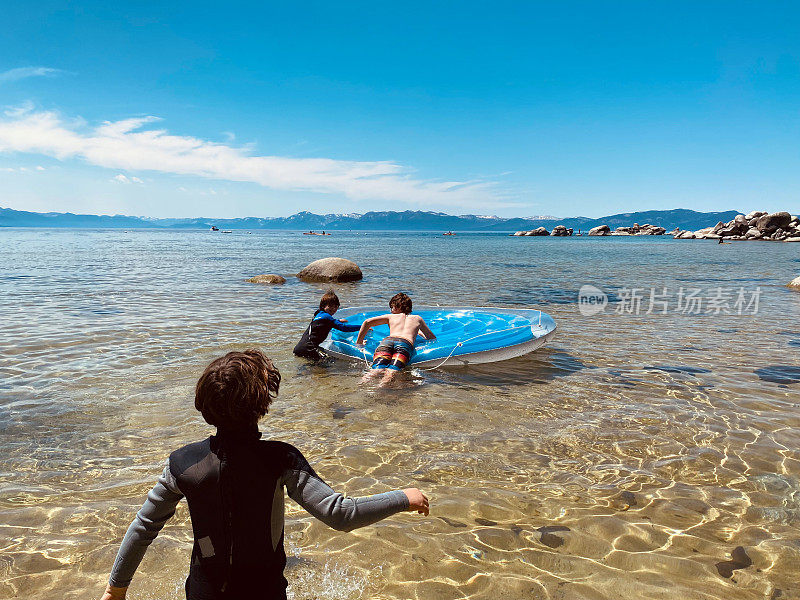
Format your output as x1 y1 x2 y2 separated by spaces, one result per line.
671 210 800 242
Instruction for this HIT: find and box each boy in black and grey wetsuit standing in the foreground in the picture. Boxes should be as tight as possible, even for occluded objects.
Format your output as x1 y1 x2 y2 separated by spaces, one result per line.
102 350 428 600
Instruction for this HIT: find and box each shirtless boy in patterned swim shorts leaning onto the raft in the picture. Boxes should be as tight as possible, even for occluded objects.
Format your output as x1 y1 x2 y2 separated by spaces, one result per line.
356 292 436 384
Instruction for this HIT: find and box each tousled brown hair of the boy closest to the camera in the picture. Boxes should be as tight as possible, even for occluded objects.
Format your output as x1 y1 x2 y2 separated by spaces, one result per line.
194 350 281 429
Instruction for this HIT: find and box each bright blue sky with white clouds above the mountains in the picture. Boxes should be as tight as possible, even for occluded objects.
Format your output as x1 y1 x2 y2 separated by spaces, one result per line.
0 2 800 217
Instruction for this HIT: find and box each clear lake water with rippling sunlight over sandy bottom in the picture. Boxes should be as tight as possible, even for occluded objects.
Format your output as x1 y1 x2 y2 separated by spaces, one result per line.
0 229 800 600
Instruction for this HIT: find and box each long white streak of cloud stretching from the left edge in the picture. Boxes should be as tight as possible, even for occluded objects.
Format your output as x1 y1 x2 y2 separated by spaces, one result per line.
0 107 513 208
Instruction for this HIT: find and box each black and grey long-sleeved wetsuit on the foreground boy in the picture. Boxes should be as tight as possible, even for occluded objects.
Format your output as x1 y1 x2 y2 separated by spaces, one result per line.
109 429 408 600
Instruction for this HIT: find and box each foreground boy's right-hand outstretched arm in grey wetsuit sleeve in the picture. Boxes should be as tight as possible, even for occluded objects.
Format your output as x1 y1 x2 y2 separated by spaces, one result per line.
283 451 429 531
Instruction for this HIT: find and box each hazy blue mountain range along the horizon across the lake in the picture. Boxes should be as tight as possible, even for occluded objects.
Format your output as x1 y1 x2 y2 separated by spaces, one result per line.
0 208 739 232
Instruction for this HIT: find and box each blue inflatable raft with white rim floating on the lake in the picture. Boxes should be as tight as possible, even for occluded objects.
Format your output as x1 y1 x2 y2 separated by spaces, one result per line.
322 306 556 368
